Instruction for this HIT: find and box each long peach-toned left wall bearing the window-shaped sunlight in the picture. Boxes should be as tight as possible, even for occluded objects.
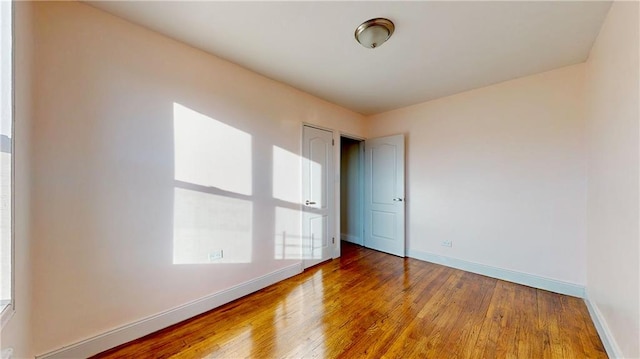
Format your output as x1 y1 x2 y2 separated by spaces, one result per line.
26 3 364 354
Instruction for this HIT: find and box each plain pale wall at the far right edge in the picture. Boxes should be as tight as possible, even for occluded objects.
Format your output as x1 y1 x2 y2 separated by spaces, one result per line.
586 2 640 358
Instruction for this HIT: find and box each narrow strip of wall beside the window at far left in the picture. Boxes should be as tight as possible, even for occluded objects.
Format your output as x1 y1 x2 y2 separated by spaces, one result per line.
0 2 34 358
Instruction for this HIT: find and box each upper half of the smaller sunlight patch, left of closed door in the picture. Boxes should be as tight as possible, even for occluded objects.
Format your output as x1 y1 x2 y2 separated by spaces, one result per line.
273 146 302 204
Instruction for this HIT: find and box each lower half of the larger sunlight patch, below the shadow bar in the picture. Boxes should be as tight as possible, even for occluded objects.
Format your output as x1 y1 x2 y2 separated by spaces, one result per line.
173 188 253 264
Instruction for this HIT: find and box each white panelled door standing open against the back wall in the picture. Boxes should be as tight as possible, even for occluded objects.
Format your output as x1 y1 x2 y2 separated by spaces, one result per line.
364 135 405 257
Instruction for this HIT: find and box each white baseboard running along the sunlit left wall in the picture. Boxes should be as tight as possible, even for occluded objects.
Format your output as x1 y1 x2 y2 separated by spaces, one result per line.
36 263 302 359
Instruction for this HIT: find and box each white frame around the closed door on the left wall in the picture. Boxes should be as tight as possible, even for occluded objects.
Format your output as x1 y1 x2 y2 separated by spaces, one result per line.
300 121 340 270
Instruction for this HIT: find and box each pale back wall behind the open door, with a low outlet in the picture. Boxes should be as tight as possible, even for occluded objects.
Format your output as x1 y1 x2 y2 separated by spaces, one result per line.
369 64 586 285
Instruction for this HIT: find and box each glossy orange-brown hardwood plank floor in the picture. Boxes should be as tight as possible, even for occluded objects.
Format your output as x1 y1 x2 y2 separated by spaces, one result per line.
95 243 607 358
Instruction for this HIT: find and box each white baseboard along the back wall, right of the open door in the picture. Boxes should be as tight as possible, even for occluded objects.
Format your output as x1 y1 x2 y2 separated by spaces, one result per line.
407 249 584 298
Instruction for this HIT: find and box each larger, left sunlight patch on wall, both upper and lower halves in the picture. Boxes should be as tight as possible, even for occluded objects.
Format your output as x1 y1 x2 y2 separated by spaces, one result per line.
173 103 253 264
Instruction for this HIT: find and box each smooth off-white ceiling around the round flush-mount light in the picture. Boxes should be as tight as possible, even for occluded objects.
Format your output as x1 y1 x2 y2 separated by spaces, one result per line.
89 1 611 115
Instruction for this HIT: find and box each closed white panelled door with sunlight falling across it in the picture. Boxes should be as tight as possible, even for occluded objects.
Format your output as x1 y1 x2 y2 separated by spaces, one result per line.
302 126 334 268
